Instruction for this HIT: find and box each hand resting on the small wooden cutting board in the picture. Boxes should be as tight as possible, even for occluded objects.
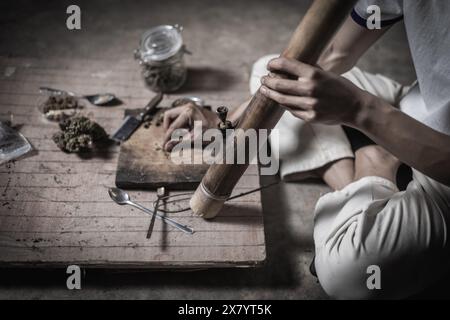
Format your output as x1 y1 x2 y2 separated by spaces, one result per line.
163 102 218 152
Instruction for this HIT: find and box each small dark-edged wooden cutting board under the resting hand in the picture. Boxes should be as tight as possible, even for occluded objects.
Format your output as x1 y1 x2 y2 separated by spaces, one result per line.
116 109 208 190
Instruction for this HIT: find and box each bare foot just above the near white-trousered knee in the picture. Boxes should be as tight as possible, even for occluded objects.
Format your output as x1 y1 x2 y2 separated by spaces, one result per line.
355 145 401 184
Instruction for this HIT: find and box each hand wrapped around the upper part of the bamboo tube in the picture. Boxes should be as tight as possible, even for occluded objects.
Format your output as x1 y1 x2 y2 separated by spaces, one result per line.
260 58 373 125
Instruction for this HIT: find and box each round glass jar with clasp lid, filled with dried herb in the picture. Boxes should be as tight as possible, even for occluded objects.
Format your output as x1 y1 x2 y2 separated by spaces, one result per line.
134 25 187 92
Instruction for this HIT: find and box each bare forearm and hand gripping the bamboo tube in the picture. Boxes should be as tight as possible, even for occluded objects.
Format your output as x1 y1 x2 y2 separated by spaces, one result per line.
261 54 450 186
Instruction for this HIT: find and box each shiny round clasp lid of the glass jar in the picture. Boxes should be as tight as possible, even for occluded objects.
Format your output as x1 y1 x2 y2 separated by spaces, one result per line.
135 25 183 62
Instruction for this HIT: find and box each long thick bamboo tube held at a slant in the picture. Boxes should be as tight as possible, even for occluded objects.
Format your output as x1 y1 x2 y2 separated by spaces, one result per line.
190 0 357 218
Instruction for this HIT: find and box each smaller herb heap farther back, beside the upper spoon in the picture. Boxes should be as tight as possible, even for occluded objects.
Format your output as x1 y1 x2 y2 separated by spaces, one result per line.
42 94 84 121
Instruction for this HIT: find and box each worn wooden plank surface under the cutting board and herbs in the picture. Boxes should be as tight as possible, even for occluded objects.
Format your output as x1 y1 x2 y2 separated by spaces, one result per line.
0 57 265 268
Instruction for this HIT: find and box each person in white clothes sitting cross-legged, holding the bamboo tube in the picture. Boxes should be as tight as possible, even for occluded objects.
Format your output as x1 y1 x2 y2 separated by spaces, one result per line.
164 0 450 299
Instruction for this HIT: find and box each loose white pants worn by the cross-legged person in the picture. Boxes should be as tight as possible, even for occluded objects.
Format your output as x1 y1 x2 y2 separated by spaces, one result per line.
250 56 450 299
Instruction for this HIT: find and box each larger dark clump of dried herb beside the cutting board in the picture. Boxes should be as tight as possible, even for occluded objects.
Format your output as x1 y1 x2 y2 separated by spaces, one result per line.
53 117 108 153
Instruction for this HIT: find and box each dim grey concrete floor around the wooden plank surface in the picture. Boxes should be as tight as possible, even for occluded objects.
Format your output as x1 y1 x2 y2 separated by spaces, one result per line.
0 0 422 299
